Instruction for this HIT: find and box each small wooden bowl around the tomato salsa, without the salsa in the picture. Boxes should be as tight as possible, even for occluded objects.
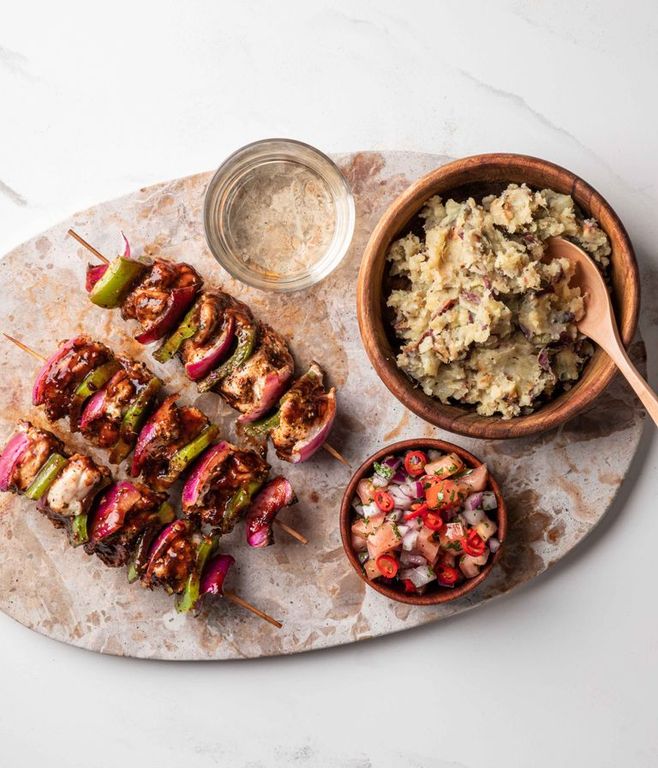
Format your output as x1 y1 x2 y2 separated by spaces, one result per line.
340 437 507 605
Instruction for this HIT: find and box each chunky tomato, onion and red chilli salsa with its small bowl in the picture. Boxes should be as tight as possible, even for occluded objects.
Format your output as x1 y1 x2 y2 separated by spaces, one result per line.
340 438 507 605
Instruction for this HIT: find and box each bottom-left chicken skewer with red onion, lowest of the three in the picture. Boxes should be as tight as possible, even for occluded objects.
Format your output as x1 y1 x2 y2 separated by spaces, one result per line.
0 421 282 628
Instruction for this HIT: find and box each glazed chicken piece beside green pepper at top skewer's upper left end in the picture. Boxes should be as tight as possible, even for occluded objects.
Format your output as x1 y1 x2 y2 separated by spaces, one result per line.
121 259 203 343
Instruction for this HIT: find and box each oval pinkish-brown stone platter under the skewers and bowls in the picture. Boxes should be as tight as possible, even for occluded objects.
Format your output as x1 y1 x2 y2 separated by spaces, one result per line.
0 152 644 660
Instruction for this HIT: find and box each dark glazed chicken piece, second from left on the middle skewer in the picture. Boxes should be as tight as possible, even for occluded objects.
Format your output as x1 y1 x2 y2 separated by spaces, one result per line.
80 358 153 448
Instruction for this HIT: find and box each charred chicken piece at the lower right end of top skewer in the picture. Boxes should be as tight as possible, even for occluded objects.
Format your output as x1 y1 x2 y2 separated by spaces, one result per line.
270 363 336 463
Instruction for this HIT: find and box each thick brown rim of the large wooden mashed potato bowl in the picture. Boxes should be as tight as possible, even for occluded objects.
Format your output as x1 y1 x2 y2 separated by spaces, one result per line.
357 153 640 439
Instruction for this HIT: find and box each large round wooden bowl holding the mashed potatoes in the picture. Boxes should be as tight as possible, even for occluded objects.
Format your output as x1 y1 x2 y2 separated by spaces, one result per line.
357 154 640 438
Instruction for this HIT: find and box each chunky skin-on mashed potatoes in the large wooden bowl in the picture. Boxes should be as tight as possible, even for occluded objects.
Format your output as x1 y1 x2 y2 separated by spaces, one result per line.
387 184 610 418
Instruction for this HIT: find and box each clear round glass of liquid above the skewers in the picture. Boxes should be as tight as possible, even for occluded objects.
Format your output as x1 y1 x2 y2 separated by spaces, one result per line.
203 139 355 291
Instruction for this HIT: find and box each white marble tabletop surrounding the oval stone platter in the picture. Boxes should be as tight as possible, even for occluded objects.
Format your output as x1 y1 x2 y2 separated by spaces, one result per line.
0 0 658 768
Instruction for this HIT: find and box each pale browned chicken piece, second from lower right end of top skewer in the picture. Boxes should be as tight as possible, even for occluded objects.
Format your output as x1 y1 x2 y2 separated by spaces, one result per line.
217 325 295 421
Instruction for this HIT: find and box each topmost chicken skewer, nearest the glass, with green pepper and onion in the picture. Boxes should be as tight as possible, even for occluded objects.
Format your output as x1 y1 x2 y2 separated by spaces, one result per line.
69 229 349 466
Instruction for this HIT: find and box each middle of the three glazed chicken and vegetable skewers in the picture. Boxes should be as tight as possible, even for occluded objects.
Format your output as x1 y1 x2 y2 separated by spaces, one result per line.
3 333 308 546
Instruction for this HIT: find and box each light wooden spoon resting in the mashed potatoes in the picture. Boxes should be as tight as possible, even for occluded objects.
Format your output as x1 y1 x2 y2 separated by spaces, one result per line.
548 237 658 425
